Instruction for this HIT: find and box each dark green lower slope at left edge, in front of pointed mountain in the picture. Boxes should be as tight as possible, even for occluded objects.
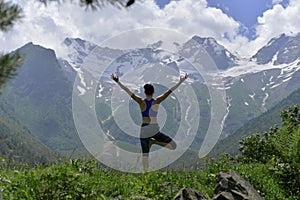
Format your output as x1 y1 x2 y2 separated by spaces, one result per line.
0 100 58 165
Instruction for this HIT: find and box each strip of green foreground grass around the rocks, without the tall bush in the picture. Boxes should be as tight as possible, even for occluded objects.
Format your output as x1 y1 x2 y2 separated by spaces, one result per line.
0 158 299 200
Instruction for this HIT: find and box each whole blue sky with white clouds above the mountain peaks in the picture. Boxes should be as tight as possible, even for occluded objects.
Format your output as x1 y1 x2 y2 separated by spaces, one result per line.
0 0 300 57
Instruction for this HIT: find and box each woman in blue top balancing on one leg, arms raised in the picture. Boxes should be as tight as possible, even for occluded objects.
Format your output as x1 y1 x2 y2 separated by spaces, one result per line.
111 74 188 171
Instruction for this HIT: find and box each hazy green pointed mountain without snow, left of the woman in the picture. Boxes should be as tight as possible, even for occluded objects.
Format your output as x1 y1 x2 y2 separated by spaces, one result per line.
0 43 83 156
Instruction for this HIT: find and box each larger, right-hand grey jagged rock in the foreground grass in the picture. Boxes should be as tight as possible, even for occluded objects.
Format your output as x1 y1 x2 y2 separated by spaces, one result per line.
213 170 263 200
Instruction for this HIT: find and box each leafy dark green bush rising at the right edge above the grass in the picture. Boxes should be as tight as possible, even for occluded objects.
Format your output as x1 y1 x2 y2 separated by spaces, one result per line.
239 105 300 196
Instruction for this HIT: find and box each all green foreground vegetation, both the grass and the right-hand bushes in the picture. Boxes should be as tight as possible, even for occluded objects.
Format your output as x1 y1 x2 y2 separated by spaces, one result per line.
0 106 300 200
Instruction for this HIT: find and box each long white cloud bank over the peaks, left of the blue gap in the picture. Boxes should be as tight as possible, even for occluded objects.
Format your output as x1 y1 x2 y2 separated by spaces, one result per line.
0 0 243 55
